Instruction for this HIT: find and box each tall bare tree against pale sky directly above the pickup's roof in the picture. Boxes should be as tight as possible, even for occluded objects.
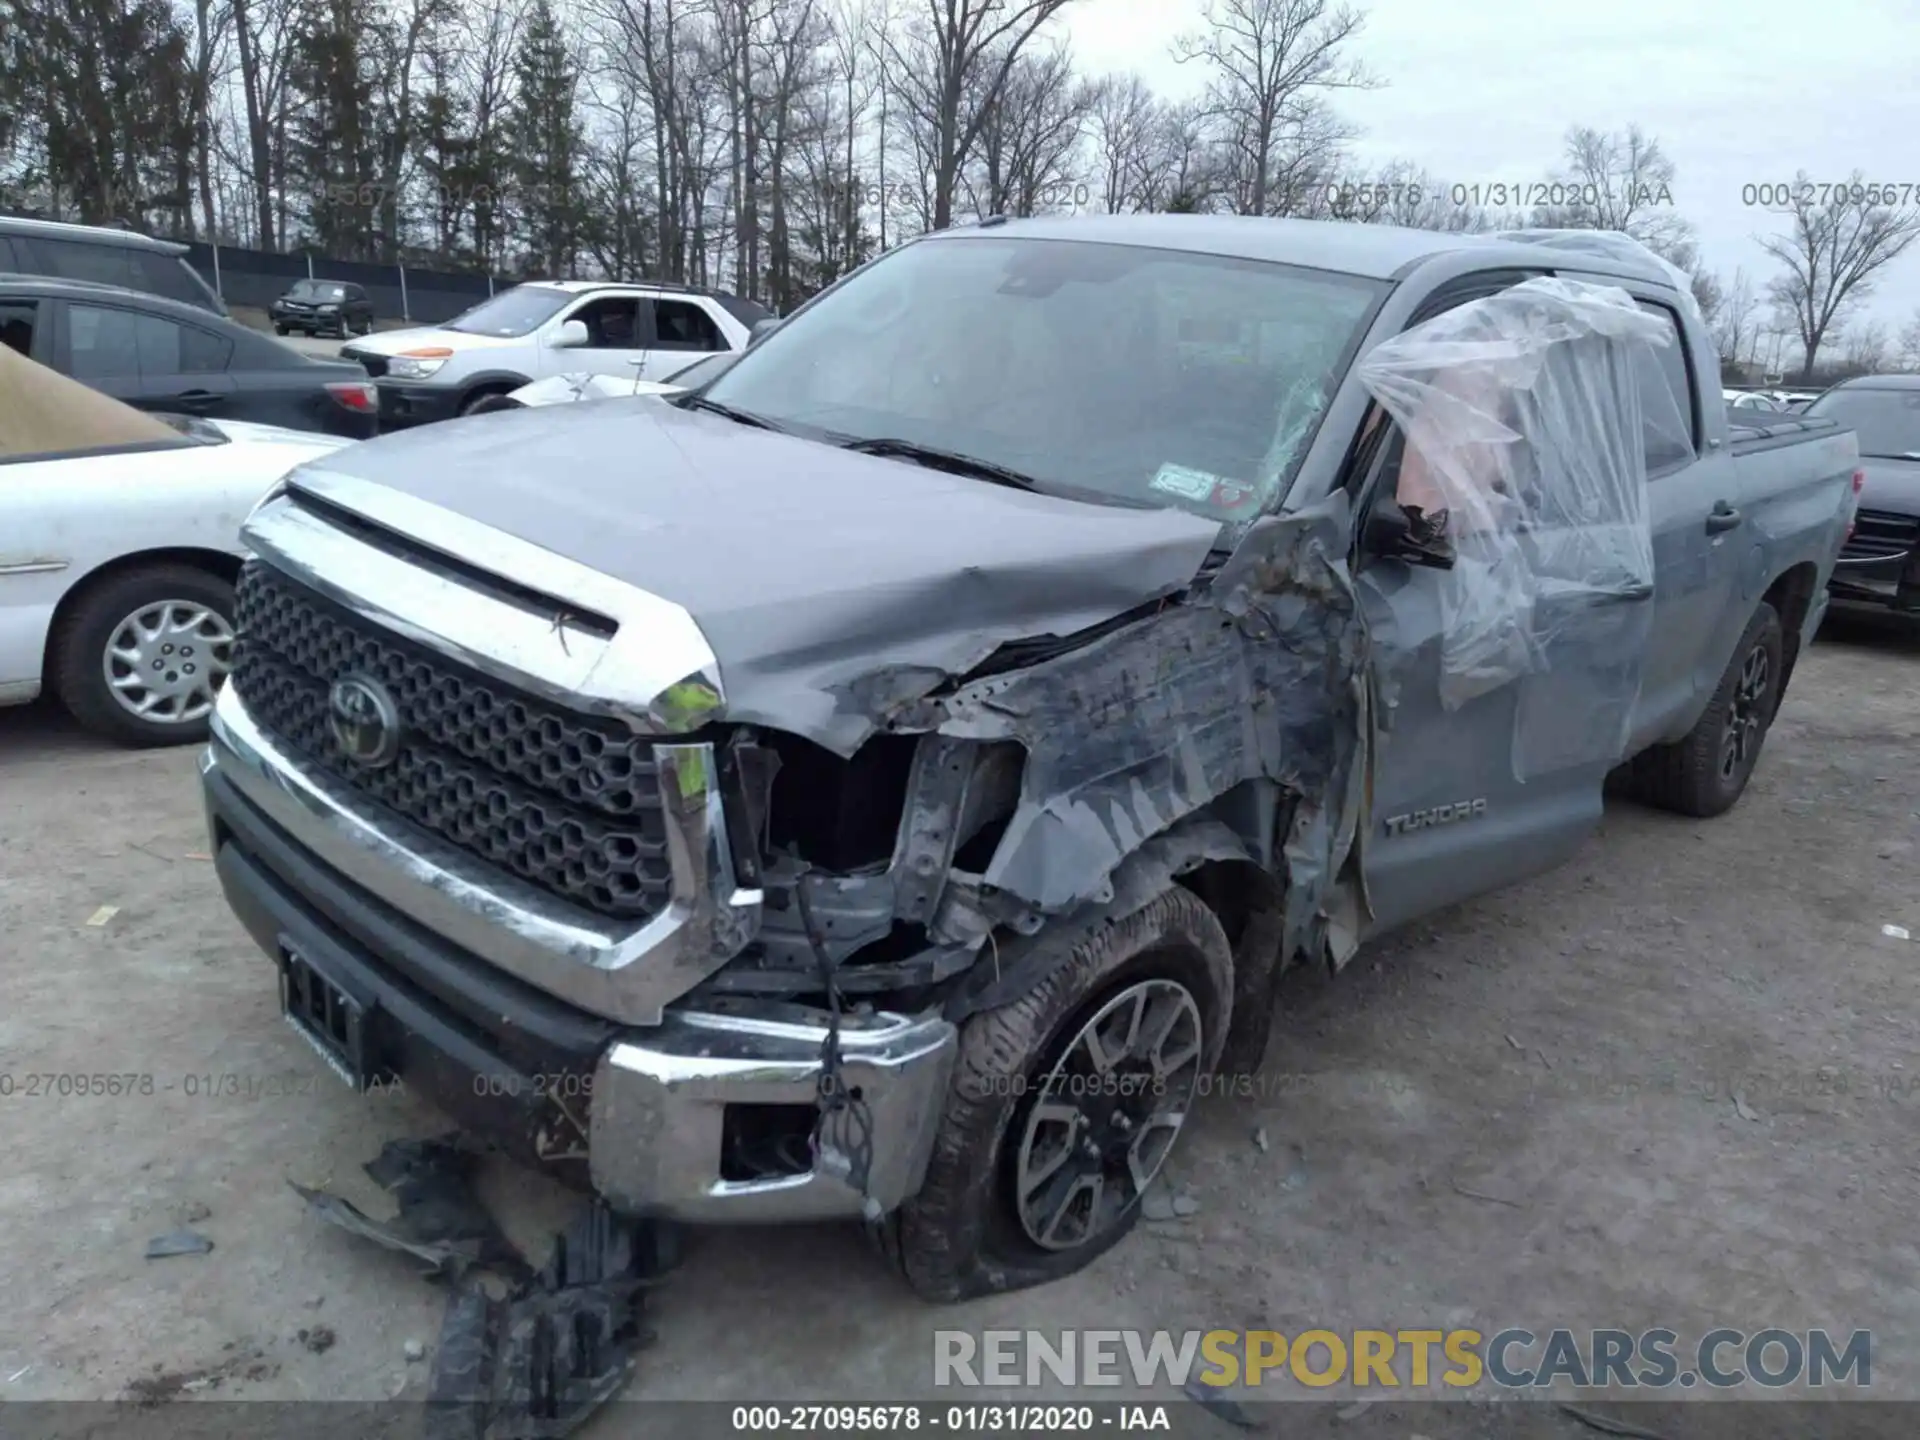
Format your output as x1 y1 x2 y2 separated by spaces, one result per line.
1173 0 1375 215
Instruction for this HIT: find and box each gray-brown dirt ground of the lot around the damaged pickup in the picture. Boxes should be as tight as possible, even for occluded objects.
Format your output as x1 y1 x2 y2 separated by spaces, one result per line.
0 626 1920 1440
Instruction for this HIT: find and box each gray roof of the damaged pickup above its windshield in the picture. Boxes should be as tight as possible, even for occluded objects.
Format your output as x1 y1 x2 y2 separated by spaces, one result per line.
927 215 1672 286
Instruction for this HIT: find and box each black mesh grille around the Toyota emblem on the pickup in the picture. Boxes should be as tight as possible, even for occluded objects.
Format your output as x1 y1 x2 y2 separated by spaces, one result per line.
228 561 672 918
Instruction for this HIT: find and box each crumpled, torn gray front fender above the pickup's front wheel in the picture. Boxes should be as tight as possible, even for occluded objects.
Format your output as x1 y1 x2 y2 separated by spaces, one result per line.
899 493 1367 971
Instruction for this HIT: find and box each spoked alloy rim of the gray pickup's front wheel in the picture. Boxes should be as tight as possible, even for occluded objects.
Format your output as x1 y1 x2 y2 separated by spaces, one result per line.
1014 979 1204 1250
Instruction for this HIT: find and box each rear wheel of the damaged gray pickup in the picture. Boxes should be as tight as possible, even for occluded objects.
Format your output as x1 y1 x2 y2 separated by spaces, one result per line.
1626 603 1786 818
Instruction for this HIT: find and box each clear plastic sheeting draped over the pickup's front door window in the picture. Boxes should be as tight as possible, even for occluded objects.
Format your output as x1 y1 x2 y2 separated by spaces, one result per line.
1357 278 1692 778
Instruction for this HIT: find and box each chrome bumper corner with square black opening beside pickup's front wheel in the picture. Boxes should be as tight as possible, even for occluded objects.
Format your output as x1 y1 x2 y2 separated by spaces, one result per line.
588 1002 958 1223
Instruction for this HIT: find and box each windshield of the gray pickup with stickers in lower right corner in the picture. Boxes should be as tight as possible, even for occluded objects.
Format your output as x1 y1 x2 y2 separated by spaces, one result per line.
707 236 1382 520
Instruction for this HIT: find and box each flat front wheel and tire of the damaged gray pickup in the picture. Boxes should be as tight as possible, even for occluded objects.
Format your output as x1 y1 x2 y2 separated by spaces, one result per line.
881 885 1233 1302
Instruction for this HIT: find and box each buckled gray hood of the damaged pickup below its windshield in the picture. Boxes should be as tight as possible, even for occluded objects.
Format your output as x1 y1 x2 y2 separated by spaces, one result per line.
309 399 1219 755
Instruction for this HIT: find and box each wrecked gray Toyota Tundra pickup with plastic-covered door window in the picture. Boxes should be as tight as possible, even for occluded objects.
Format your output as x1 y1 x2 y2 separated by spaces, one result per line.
202 217 1857 1300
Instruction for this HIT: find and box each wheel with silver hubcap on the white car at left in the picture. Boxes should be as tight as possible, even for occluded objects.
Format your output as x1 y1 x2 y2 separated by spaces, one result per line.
52 564 234 747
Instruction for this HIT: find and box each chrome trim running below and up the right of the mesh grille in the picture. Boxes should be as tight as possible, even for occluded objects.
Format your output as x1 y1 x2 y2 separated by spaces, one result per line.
204 685 760 1025
